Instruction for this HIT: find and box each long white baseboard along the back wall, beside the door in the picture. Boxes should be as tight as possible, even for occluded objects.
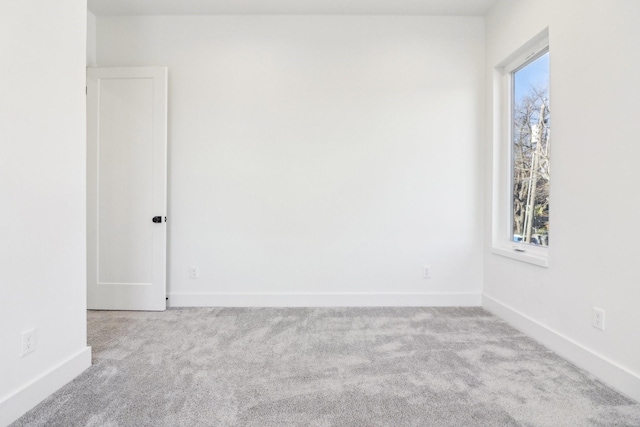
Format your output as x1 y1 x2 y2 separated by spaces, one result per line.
168 293 481 307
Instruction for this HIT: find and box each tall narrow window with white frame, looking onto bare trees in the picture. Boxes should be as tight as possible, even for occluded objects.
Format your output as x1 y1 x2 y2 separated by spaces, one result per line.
493 30 551 267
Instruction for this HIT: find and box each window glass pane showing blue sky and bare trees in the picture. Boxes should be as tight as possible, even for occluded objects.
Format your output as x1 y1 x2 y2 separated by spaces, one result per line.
511 49 551 246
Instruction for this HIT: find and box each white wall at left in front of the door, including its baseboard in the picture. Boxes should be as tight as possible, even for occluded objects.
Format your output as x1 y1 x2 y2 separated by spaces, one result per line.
0 0 91 425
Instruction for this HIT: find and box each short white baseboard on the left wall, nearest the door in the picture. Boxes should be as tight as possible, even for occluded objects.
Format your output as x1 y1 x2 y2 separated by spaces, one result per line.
0 347 91 427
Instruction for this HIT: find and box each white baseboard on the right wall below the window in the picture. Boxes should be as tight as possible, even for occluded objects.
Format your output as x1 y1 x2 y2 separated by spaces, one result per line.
482 294 640 402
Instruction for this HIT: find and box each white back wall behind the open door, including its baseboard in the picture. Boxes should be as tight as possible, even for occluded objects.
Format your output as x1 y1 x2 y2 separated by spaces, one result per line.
97 16 484 305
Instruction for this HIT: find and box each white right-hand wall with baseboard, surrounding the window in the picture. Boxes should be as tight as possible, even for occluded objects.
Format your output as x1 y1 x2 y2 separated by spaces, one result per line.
484 0 640 399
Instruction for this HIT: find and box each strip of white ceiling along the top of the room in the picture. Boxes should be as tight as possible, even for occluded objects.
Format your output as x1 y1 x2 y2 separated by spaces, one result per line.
88 0 497 16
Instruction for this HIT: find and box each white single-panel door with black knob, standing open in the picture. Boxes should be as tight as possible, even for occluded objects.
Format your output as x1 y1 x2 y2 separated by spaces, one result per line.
87 67 167 310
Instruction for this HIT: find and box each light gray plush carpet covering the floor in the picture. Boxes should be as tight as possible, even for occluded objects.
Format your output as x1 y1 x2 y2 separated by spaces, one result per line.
13 308 640 427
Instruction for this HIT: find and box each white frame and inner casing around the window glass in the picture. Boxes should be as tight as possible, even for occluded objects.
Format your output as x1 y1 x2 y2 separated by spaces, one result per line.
491 28 551 267
